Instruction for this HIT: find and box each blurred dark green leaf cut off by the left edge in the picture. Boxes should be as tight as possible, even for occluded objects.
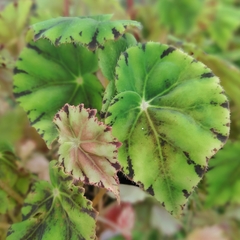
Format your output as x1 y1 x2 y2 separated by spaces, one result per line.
0 141 30 214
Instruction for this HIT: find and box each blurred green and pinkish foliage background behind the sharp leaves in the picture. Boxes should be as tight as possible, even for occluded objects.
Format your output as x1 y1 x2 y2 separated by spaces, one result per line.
0 0 240 240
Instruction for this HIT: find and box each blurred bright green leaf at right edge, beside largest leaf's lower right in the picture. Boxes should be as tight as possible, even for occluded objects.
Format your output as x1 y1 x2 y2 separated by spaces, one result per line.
206 141 240 207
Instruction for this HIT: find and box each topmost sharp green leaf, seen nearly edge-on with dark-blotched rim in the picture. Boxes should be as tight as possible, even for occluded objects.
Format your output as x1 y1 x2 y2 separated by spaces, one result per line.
32 15 141 50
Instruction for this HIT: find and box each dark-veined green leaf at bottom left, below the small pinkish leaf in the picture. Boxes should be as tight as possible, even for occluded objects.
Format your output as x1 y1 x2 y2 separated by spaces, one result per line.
7 161 97 240
